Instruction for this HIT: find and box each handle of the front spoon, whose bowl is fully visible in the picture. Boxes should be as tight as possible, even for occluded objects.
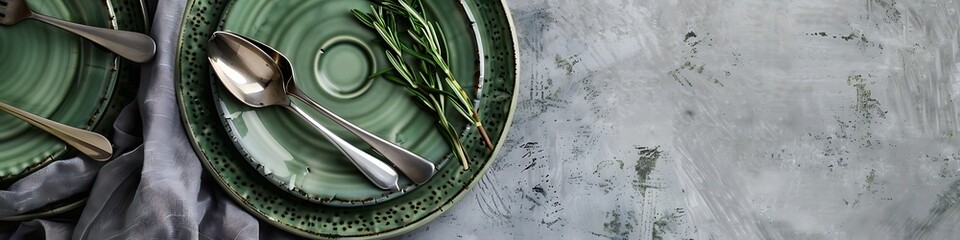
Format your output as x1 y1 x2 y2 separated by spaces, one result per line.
288 103 400 191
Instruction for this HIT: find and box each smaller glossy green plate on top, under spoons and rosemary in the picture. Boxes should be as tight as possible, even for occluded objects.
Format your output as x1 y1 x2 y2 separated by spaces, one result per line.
211 0 480 206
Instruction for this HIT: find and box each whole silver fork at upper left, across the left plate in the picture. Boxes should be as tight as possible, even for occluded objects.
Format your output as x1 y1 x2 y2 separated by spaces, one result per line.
0 0 157 63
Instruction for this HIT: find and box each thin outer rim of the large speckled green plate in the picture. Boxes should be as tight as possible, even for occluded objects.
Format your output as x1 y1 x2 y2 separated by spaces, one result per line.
174 0 522 239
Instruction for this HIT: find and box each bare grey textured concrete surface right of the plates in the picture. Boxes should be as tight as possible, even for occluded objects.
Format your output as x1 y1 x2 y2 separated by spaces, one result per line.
406 0 960 239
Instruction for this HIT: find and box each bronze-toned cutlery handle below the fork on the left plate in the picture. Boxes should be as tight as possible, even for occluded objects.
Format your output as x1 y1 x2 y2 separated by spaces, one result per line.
0 102 113 161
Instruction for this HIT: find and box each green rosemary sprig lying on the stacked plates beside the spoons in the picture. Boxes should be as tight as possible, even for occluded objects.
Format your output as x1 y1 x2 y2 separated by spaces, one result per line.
353 0 493 170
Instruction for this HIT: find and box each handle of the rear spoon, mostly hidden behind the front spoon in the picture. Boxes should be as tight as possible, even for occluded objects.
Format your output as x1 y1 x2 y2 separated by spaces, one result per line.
289 88 437 184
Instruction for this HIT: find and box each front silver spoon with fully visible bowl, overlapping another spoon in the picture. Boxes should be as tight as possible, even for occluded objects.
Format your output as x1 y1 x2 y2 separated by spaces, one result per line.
207 33 399 190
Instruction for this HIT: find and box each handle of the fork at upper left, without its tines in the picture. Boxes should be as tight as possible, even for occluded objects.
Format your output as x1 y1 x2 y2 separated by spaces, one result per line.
31 13 157 63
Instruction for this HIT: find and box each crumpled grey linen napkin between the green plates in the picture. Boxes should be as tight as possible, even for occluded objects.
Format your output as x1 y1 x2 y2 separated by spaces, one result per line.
0 0 291 239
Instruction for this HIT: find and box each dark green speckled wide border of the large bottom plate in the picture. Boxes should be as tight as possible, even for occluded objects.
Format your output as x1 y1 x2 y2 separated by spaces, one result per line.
175 0 519 239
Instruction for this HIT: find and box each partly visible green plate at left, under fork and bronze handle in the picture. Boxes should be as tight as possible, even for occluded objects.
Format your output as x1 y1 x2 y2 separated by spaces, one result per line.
0 0 145 181
